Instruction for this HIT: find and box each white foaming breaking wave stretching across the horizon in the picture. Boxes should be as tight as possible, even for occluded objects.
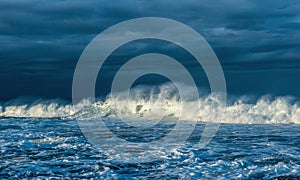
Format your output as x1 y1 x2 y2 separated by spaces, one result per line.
0 84 300 124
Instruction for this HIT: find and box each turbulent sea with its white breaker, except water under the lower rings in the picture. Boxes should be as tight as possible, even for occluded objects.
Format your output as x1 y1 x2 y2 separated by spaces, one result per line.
0 86 300 179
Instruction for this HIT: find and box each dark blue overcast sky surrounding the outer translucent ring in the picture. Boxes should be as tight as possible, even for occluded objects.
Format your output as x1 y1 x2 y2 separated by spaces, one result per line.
0 0 300 100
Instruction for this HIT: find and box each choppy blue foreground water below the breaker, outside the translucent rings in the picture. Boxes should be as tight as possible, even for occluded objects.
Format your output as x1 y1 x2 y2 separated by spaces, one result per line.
0 118 300 179
